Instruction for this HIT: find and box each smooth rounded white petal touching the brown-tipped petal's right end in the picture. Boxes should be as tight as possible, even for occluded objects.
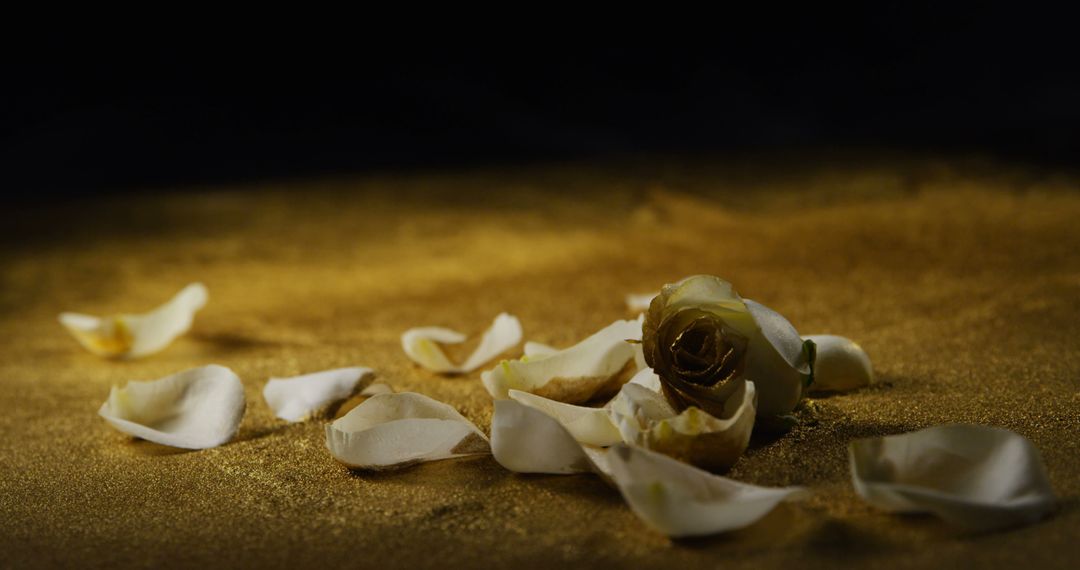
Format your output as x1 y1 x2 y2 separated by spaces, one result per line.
491 399 593 474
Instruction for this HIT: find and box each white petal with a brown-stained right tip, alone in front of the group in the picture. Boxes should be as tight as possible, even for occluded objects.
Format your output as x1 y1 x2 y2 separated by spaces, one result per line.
326 392 490 470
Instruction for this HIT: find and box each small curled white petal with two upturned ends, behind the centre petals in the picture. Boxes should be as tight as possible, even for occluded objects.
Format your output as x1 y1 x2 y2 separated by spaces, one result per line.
402 313 522 374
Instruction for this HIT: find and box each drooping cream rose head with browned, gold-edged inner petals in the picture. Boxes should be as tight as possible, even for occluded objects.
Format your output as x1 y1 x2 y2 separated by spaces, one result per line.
642 275 815 422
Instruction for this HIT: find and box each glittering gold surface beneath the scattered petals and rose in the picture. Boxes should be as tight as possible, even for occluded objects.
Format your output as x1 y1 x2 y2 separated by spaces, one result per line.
0 153 1080 569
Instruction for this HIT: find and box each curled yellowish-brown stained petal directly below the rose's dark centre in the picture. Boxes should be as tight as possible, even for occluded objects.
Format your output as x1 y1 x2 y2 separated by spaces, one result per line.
611 380 756 472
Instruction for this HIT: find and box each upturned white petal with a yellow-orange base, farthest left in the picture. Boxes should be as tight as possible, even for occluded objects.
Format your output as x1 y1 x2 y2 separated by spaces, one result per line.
59 283 207 358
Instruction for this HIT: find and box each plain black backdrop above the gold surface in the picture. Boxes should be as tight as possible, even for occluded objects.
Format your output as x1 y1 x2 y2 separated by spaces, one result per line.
0 3 1080 201
